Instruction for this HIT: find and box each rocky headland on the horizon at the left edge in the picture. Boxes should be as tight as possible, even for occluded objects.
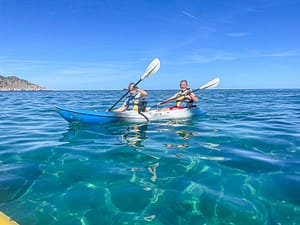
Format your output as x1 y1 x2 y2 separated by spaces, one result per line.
0 75 46 91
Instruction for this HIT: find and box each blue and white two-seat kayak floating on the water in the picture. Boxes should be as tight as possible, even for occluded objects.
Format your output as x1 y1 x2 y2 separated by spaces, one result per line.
56 107 205 124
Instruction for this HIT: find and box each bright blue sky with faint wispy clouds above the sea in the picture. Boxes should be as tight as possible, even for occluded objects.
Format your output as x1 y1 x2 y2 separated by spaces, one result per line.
0 0 300 90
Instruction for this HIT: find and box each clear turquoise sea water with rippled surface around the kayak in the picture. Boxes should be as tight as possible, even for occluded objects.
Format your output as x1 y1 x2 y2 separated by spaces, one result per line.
0 90 300 225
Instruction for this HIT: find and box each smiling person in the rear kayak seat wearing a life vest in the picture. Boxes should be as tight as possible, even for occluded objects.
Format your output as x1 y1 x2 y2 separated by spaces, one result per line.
157 80 198 111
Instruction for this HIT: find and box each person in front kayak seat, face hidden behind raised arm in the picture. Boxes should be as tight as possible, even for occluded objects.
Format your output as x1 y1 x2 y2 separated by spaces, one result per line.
113 83 148 112
